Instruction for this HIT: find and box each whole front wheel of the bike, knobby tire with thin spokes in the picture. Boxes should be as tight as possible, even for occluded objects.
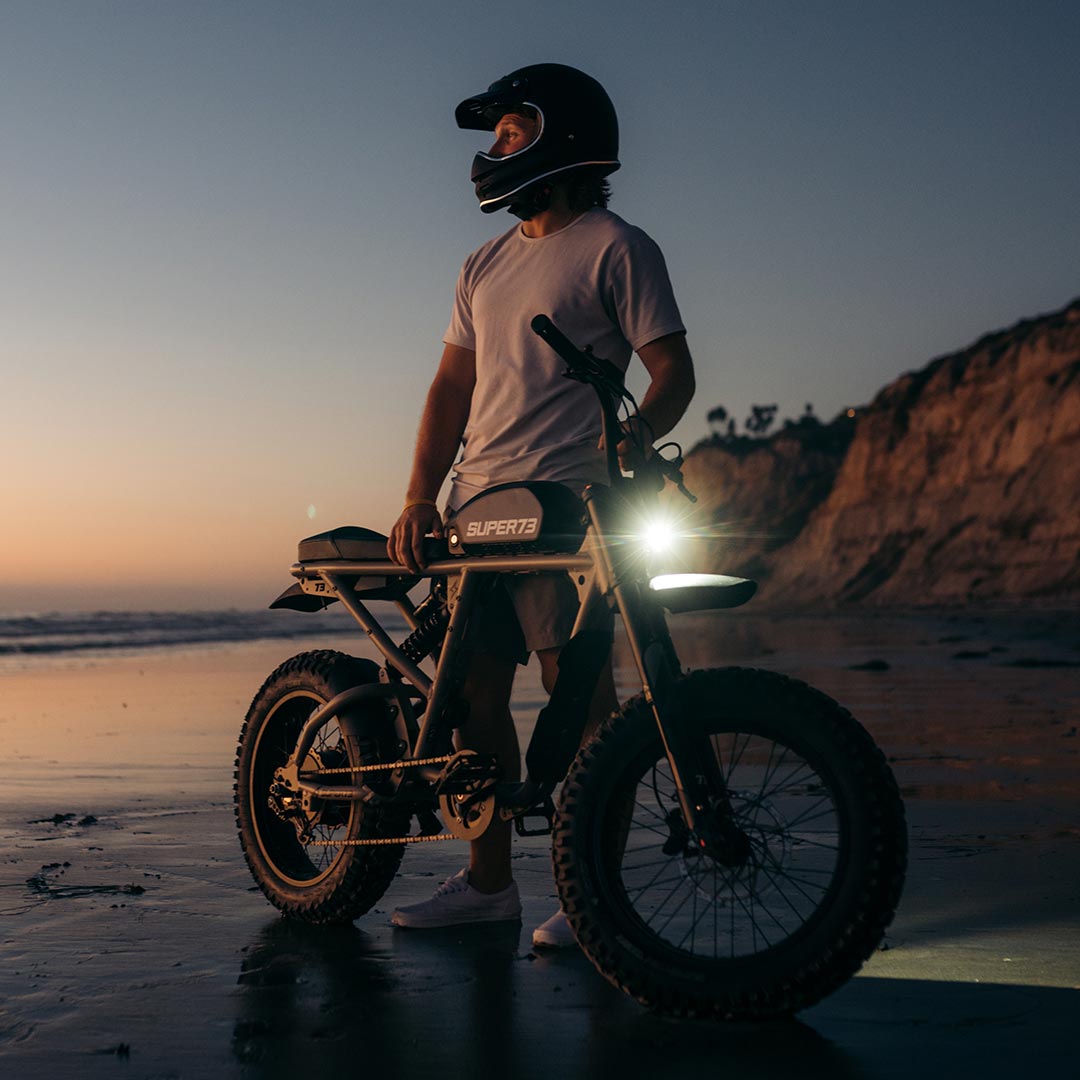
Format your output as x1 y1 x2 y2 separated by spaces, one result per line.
554 669 907 1020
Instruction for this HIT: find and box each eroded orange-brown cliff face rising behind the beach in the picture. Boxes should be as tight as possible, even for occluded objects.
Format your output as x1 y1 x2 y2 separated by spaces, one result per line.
686 300 1080 607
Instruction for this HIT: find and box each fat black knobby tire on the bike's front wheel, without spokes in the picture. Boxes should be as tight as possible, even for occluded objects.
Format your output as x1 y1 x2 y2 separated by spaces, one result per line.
553 667 907 1020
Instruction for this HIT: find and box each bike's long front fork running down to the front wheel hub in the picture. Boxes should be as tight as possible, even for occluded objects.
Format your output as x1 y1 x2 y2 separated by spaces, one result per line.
584 486 750 866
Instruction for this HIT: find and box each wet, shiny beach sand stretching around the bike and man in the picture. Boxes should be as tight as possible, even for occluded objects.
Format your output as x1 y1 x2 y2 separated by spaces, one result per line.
0 613 1080 1078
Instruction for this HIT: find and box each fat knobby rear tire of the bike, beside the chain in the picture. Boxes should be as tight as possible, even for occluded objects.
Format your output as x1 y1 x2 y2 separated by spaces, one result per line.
233 650 408 923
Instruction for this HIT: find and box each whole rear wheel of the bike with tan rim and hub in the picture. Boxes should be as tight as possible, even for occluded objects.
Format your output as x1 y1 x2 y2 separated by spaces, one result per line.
235 650 408 922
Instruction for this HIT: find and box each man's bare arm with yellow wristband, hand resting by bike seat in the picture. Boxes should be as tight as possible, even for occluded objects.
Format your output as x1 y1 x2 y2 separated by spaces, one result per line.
387 345 476 572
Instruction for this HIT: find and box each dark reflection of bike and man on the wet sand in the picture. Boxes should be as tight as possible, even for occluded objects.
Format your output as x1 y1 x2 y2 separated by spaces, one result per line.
232 921 862 1080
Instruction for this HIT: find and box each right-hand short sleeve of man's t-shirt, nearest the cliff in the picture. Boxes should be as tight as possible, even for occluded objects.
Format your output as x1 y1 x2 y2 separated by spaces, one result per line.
610 232 686 352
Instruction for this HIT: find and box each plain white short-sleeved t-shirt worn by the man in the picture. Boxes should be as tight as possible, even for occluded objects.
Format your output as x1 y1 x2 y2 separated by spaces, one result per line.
443 208 685 507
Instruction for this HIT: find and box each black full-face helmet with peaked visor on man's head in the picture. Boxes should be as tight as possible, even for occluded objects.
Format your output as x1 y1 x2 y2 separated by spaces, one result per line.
454 64 619 216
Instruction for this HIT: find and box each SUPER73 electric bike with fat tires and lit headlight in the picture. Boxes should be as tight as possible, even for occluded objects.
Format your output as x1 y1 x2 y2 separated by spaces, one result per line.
235 315 907 1020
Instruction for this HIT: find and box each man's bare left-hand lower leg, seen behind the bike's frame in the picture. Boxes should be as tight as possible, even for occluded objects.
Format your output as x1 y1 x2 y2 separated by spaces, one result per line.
461 653 522 893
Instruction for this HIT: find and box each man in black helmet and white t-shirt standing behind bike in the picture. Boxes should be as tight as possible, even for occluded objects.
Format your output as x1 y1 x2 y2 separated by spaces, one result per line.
387 64 694 946
